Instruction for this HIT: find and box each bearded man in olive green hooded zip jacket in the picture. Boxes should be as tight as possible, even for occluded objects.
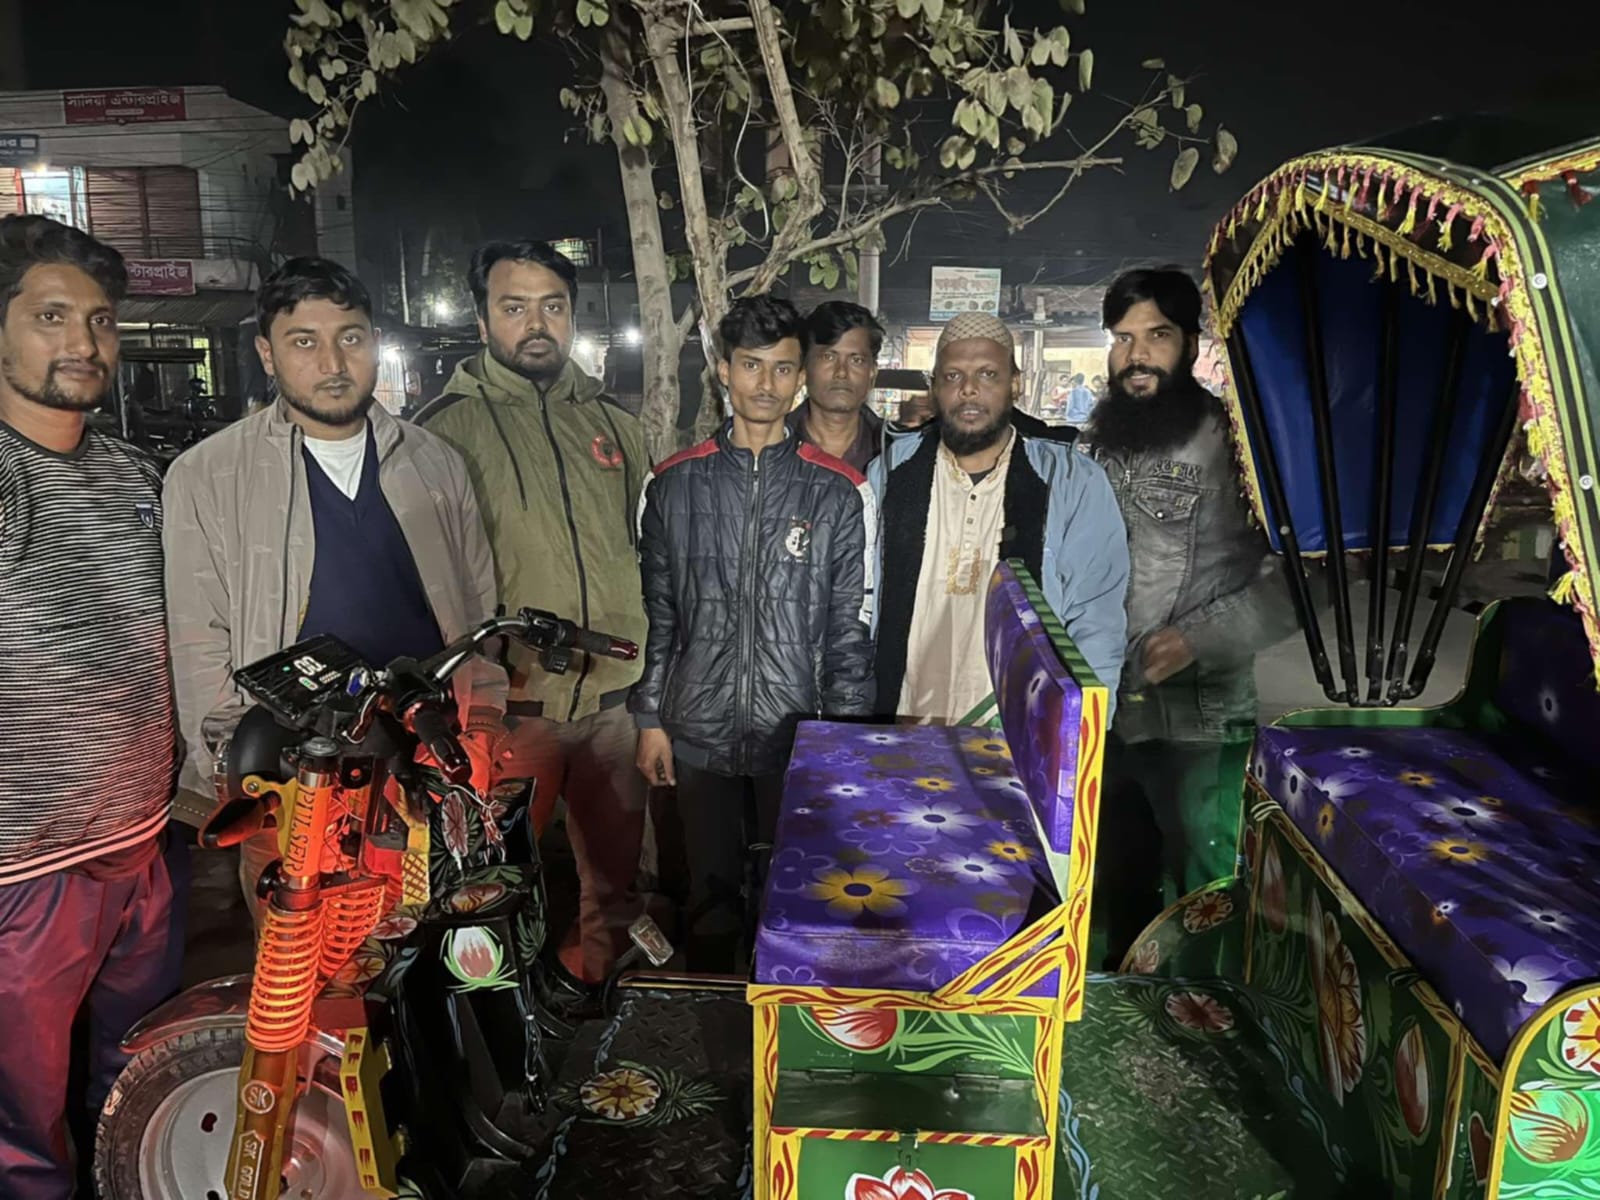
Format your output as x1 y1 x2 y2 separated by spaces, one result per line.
416 242 650 982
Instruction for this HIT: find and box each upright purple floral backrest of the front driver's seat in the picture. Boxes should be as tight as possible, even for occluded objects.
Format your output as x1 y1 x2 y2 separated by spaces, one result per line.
984 562 1096 854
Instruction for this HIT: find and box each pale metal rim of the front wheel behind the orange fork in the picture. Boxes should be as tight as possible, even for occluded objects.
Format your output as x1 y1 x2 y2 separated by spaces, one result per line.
139 1067 366 1200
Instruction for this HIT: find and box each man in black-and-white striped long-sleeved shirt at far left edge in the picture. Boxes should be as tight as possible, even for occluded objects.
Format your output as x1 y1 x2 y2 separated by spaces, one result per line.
0 216 176 1200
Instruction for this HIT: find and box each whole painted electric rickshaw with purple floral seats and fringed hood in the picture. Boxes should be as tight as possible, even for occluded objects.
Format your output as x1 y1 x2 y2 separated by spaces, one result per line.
101 122 1600 1200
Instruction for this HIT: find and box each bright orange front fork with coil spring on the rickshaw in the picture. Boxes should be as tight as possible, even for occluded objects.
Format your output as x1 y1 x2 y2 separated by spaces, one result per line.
227 738 338 1200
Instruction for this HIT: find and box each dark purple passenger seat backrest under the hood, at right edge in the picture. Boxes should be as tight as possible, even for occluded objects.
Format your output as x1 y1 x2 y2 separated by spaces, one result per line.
1494 597 1600 780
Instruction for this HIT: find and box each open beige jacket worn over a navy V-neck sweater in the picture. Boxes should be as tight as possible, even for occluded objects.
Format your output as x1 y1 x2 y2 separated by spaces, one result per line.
162 402 506 818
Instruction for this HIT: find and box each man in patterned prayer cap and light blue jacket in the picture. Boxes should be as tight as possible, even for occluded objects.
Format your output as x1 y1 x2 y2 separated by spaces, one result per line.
870 312 1128 723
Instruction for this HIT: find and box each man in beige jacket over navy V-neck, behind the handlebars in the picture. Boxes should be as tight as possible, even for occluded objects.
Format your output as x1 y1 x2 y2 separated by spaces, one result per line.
163 258 506 909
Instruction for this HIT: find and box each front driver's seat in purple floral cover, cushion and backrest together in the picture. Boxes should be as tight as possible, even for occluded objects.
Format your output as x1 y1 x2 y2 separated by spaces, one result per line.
755 565 1082 992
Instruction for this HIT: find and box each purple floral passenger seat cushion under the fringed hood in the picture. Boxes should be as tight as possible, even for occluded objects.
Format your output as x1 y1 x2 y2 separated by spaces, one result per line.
1250 728 1600 1059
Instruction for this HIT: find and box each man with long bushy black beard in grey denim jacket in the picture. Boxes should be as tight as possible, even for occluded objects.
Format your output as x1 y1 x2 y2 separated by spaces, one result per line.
1085 267 1294 965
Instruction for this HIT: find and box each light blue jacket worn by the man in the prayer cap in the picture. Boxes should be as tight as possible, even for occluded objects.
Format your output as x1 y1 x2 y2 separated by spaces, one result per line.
867 432 1128 720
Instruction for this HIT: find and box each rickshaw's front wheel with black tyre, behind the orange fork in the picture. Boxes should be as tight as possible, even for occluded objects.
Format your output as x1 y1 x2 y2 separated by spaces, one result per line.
94 1024 377 1200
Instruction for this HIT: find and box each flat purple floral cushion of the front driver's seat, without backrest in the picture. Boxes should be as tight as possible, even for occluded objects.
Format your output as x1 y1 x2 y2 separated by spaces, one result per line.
755 722 1059 992
